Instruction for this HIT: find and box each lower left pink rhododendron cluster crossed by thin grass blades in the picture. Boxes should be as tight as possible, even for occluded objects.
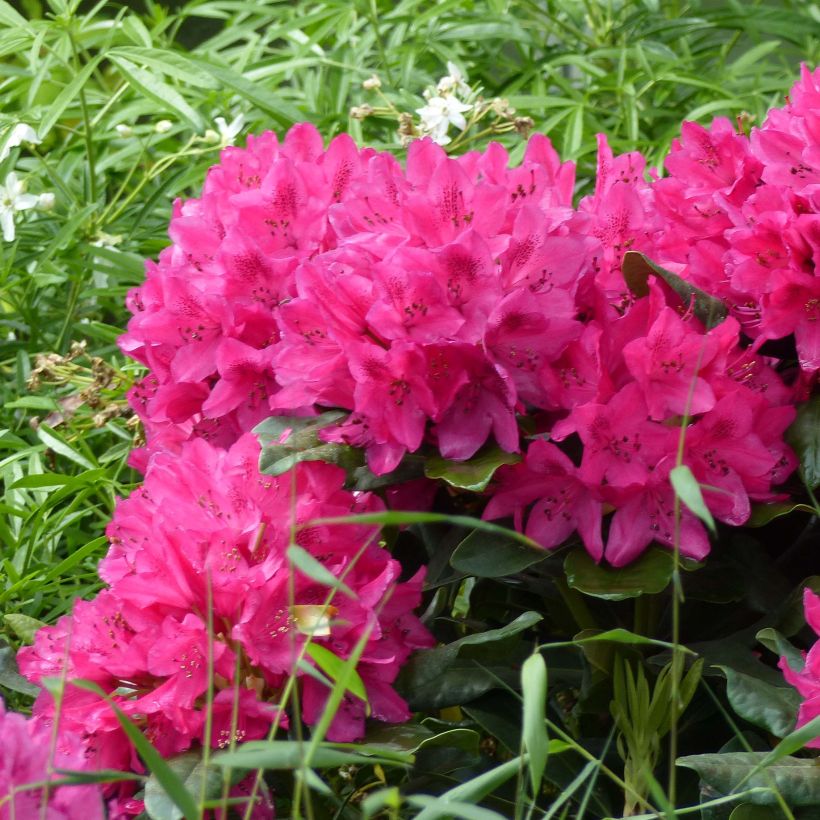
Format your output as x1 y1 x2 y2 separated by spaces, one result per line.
19 436 432 769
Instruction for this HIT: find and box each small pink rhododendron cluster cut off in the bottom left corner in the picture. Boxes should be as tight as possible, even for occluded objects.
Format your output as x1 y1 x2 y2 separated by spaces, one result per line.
0 699 106 820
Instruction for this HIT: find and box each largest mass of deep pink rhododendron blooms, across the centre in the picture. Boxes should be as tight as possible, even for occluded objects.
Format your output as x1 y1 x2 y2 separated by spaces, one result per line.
121 86 808 565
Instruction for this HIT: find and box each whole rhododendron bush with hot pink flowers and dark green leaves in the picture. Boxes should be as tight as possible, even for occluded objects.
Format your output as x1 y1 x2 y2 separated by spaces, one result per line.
0 62 820 817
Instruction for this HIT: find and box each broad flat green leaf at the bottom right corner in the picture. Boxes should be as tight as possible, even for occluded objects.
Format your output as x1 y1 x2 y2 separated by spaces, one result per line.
677 752 820 806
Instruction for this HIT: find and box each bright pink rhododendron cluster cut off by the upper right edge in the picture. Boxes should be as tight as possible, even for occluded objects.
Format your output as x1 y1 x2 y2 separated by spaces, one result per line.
653 66 820 374
